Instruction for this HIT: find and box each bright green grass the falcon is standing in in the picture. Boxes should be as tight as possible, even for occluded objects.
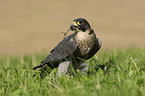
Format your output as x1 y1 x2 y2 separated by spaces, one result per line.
0 48 145 96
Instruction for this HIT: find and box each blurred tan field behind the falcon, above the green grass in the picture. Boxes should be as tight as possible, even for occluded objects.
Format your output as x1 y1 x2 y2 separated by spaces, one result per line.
0 0 145 55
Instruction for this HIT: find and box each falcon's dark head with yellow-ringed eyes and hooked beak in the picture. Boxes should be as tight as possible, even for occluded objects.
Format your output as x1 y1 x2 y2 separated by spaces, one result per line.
70 18 91 32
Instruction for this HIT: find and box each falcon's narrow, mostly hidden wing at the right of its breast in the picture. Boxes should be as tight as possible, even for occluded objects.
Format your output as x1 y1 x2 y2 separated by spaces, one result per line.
86 38 102 60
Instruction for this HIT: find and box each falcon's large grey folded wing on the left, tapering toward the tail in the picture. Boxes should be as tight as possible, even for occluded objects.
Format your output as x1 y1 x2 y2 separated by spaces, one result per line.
33 33 77 70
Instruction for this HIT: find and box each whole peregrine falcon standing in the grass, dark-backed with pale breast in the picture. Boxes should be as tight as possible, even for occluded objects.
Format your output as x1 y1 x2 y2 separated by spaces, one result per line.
33 18 101 78
